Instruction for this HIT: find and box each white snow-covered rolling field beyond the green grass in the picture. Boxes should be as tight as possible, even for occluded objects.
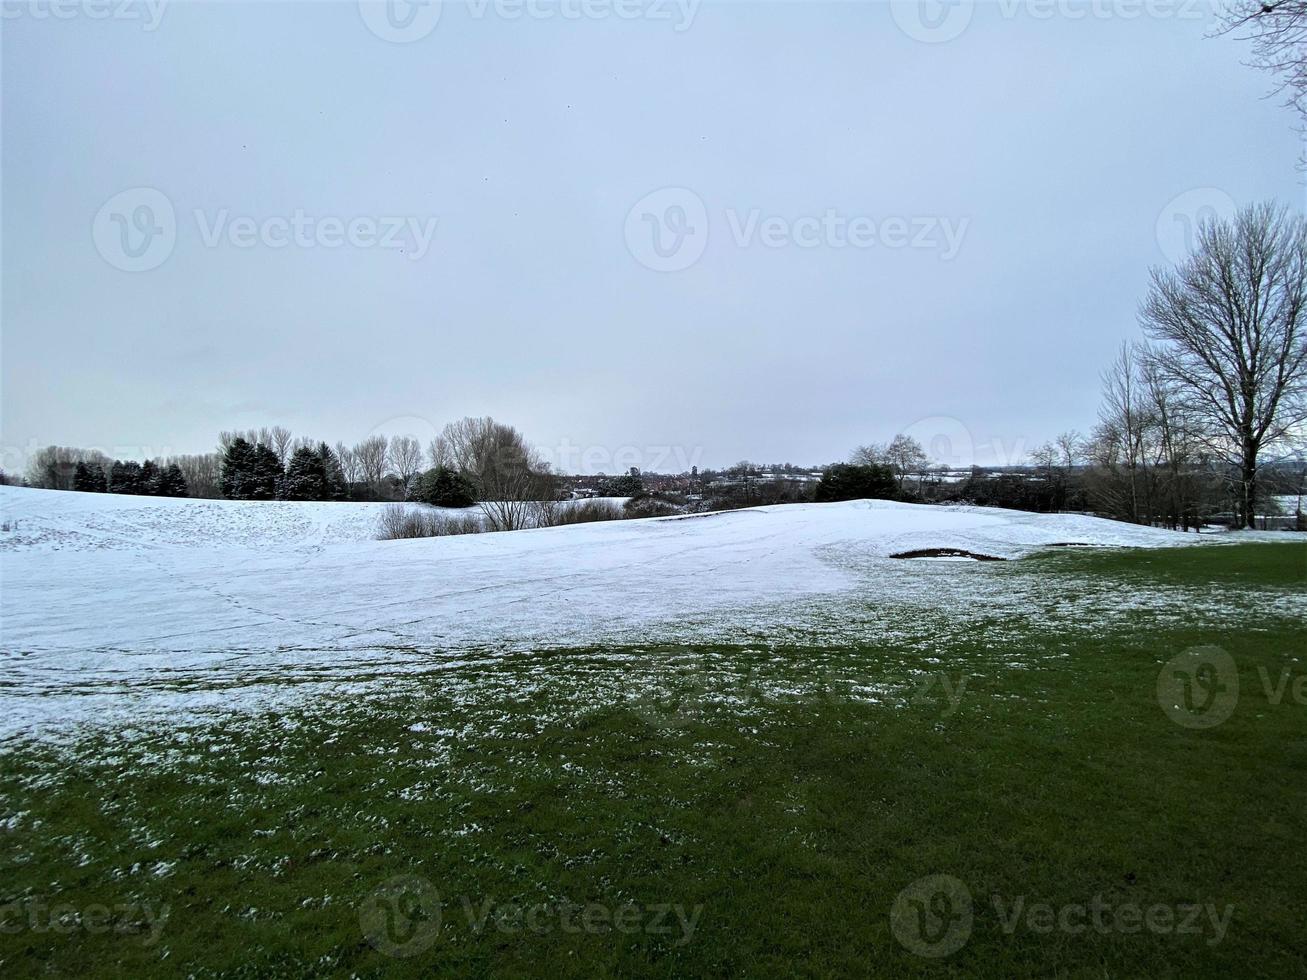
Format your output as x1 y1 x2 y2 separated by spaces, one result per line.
0 487 1291 736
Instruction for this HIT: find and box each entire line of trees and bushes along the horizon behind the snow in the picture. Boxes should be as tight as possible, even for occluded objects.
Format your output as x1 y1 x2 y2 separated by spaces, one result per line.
15 203 1307 538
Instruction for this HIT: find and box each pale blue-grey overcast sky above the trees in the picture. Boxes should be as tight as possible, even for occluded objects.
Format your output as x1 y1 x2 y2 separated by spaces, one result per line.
0 0 1304 472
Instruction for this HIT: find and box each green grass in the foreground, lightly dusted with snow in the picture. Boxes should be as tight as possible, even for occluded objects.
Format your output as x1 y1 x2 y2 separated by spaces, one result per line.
0 545 1307 977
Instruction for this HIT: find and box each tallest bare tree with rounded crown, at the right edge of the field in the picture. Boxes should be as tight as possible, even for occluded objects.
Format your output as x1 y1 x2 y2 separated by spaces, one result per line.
1140 204 1307 527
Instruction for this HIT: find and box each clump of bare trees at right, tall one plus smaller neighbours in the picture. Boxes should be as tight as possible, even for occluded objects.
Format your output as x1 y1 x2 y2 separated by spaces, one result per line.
1084 203 1307 528
